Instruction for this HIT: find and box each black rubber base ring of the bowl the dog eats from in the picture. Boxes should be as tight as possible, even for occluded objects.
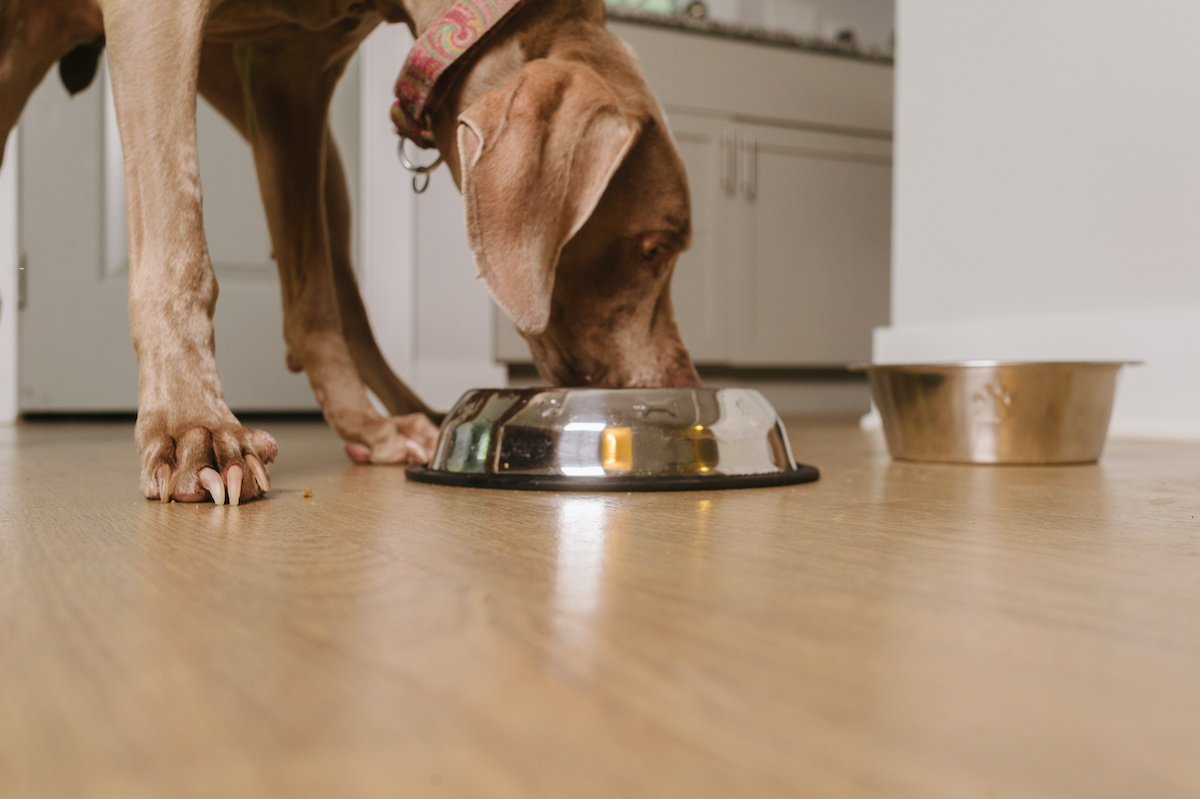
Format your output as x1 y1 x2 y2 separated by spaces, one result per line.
404 464 821 492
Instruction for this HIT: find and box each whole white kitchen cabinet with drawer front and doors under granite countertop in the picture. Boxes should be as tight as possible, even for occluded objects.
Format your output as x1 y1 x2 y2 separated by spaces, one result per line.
497 24 892 368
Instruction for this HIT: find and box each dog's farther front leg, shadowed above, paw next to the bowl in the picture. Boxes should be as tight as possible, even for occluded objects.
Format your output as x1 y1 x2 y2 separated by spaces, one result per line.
235 32 437 463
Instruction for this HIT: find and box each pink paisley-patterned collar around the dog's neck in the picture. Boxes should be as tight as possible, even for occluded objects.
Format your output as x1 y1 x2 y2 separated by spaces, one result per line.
391 0 526 149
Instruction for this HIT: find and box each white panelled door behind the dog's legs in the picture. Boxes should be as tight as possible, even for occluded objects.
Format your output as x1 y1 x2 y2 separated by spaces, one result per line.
19 57 359 413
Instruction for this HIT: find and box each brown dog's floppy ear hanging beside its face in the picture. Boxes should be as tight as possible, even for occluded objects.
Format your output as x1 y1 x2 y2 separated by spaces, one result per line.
458 59 637 334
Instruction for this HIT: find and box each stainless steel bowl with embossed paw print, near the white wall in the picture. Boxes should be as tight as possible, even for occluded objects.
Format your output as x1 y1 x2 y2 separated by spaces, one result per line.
853 361 1126 463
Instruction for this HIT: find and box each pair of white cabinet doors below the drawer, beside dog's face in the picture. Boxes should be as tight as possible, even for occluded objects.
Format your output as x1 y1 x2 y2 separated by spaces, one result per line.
670 113 892 367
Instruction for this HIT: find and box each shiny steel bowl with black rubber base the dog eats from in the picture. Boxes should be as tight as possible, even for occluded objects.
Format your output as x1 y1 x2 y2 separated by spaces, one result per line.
408 389 818 491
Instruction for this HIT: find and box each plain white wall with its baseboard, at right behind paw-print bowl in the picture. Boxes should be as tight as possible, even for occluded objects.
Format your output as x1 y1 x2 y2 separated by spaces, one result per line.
875 0 1200 437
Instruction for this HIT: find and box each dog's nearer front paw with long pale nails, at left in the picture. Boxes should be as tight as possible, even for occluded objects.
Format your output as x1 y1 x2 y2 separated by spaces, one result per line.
137 420 278 505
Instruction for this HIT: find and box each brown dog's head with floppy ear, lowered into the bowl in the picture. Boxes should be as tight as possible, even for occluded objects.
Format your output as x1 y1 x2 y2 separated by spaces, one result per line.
446 34 698 386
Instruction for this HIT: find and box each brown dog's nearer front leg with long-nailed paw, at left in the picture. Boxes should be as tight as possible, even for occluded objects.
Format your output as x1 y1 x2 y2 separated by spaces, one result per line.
103 0 276 504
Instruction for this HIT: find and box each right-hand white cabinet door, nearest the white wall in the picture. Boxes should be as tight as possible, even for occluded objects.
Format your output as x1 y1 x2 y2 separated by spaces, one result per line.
731 125 892 367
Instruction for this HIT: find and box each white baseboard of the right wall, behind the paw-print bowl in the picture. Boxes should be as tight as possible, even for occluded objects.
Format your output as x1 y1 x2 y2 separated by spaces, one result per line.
875 306 1200 440
